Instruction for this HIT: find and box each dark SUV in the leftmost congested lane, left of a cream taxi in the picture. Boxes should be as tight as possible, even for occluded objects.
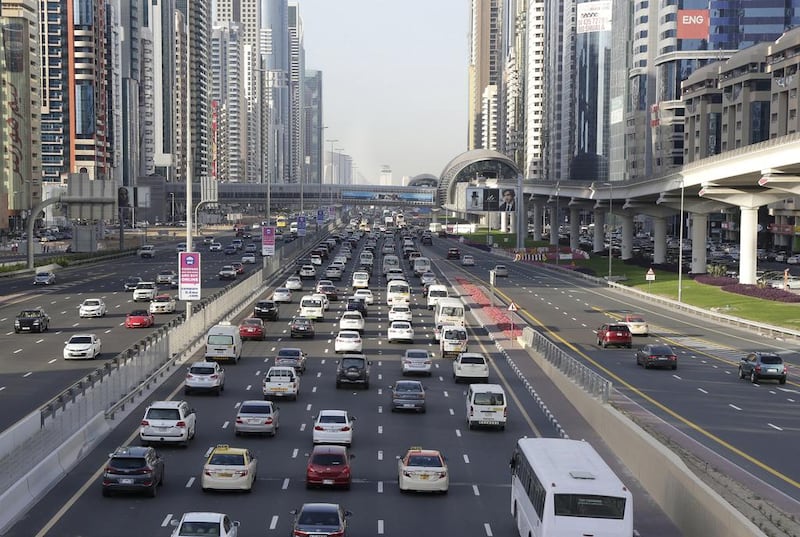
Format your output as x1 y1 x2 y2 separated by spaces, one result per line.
101 446 164 498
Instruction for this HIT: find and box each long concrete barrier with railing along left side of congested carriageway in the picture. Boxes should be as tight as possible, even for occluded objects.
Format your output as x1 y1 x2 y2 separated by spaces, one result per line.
0 224 334 534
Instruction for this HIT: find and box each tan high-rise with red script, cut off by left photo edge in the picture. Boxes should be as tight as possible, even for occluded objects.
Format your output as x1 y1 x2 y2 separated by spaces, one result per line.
0 0 42 230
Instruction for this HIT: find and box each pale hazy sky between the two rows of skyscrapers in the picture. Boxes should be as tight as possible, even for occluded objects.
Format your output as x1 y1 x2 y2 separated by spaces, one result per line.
299 0 470 183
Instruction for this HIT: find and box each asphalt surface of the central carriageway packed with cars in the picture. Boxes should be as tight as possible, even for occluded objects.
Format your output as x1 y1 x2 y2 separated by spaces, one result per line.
7 230 679 537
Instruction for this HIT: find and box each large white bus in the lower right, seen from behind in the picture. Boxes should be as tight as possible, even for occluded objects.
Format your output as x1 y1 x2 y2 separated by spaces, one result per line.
511 438 633 537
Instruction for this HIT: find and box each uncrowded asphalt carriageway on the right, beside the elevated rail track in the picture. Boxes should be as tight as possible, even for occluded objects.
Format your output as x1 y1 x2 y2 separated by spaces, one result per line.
432 239 800 500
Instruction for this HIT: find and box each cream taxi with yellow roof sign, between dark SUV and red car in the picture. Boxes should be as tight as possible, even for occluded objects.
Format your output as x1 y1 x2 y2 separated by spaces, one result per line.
200 444 258 492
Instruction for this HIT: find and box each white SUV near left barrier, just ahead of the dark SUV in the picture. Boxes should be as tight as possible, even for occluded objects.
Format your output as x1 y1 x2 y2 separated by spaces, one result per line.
139 401 197 445
